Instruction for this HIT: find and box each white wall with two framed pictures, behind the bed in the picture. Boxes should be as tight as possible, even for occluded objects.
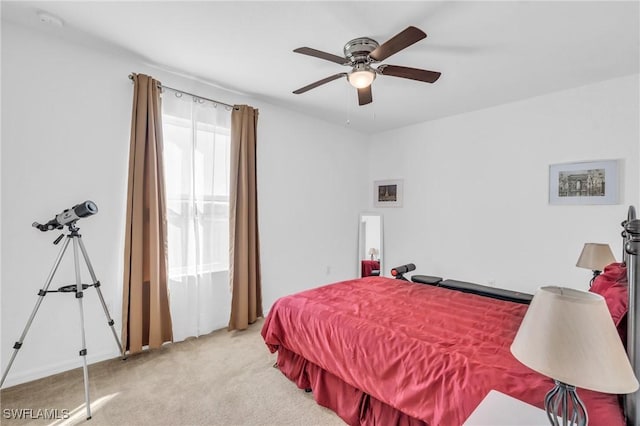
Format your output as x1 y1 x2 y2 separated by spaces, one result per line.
369 75 640 292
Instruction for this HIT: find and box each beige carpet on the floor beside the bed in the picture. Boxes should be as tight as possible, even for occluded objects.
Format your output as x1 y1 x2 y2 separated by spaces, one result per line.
0 320 345 426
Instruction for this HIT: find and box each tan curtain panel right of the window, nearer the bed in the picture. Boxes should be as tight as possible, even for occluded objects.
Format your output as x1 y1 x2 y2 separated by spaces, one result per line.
229 105 262 330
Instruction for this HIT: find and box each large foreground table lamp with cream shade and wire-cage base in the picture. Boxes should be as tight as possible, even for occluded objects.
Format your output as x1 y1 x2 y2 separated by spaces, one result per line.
511 286 638 426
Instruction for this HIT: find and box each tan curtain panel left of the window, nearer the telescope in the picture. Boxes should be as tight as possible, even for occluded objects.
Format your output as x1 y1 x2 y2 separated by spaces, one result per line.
122 74 173 354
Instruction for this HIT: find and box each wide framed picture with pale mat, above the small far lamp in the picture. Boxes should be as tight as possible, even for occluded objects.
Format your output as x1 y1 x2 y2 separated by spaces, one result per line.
549 160 618 205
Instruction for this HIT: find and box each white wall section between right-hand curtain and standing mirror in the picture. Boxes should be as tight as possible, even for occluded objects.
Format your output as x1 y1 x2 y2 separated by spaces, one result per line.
258 106 367 310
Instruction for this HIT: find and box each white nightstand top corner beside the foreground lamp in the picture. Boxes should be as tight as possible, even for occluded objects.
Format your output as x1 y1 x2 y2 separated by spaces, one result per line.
463 390 550 426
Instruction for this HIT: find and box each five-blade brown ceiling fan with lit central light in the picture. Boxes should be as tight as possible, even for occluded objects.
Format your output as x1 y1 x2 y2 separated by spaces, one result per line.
293 27 440 105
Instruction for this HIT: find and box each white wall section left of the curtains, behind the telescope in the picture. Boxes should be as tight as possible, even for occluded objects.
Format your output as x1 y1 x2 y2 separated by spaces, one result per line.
0 21 131 386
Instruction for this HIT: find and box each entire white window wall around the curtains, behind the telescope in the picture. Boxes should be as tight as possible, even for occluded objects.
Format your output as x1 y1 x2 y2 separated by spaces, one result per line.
0 21 367 386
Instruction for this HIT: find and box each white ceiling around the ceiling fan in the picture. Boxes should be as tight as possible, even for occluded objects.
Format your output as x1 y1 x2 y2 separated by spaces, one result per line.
2 1 640 133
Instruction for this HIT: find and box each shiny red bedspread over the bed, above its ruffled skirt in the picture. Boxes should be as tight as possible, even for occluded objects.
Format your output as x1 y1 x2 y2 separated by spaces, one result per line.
262 277 624 426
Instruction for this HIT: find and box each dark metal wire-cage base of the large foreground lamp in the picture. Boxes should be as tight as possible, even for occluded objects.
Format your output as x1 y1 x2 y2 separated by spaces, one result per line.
544 380 588 426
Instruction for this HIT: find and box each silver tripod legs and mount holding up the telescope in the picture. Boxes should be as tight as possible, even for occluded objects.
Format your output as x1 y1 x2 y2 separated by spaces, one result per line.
0 222 122 420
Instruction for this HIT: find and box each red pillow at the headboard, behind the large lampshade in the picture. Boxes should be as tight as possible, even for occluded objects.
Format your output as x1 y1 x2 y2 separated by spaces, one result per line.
589 263 629 342
